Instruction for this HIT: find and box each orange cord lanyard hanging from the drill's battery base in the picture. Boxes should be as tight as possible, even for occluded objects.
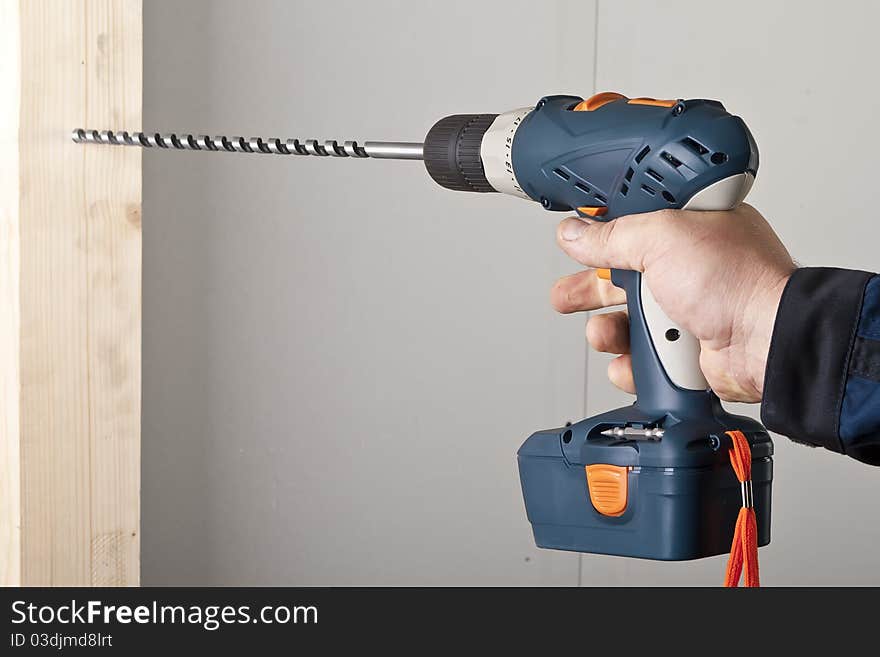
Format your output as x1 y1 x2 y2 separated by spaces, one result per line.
724 431 761 587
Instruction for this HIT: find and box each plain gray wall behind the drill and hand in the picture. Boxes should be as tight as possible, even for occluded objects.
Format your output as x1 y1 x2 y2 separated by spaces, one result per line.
142 0 880 585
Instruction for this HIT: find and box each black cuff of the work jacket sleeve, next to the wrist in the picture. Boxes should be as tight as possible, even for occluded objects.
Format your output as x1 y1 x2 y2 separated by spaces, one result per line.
761 267 874 453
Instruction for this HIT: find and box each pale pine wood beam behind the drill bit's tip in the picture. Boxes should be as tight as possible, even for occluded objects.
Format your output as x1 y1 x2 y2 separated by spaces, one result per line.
0 0 142 585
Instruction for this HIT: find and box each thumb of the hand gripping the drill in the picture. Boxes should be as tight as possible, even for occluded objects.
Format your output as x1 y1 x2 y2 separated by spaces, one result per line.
556 212 665 271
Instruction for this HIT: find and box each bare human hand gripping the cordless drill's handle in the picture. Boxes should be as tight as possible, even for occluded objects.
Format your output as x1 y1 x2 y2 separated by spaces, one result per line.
551 204 796 402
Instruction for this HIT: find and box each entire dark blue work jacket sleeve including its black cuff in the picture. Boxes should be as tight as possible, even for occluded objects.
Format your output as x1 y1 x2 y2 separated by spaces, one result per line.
761 267 880 465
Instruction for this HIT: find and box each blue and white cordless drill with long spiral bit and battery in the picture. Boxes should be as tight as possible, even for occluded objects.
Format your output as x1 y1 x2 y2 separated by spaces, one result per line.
79 92 773 560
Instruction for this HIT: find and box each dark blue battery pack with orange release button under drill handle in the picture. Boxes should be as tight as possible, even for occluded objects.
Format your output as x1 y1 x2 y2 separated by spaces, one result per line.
518 416 773 561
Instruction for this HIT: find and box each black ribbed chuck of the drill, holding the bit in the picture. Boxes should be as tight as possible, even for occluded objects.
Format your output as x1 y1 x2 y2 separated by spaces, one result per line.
423 114 498 192
